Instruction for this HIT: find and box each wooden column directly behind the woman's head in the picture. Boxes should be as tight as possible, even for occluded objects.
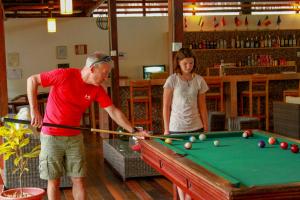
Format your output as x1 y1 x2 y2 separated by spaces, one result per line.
168 0 183 74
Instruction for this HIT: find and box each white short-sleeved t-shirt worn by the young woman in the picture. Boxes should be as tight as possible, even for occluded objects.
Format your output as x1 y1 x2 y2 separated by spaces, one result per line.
164 74 208 132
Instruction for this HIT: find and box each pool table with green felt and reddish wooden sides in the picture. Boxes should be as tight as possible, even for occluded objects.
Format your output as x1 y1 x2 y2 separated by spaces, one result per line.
141 130 300 200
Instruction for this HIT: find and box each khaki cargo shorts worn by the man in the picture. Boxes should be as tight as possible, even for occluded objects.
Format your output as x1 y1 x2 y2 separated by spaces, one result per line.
39 133 86 180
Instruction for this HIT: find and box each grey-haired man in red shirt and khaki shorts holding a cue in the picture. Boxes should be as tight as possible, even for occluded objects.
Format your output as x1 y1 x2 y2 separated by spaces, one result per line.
27 52 136 200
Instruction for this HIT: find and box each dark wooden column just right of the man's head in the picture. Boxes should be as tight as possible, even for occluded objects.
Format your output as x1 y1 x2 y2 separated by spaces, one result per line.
108 0 121 130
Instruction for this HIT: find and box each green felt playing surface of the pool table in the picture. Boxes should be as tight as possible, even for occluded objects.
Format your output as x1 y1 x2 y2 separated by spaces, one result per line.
157 132 300 187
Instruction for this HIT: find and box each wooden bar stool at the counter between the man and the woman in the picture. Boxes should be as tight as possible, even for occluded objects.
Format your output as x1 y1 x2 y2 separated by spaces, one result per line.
127 80 152 130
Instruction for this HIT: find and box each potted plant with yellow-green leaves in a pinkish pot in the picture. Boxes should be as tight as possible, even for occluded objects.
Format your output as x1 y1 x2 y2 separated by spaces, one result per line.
0 116 45 200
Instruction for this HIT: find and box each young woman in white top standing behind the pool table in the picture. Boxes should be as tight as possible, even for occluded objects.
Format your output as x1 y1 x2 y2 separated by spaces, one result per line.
163 48 208 200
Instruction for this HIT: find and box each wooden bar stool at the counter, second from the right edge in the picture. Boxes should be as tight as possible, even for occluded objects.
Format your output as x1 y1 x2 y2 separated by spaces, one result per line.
240 75 269 130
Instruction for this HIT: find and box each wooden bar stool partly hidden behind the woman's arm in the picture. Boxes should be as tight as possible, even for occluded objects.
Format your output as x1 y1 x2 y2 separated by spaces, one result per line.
205 77 224 112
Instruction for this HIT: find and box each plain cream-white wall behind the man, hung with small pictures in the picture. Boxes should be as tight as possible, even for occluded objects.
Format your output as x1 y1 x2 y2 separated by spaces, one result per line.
5 17 168 98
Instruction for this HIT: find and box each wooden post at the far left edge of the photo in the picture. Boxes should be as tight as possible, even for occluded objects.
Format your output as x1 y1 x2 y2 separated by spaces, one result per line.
0 2 8 117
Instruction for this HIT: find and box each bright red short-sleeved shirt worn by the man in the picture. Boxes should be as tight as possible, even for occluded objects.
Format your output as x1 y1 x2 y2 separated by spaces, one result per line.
40 68 112 136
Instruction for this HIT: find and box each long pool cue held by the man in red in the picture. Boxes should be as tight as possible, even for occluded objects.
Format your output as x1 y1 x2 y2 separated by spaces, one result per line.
1 117 183 140
